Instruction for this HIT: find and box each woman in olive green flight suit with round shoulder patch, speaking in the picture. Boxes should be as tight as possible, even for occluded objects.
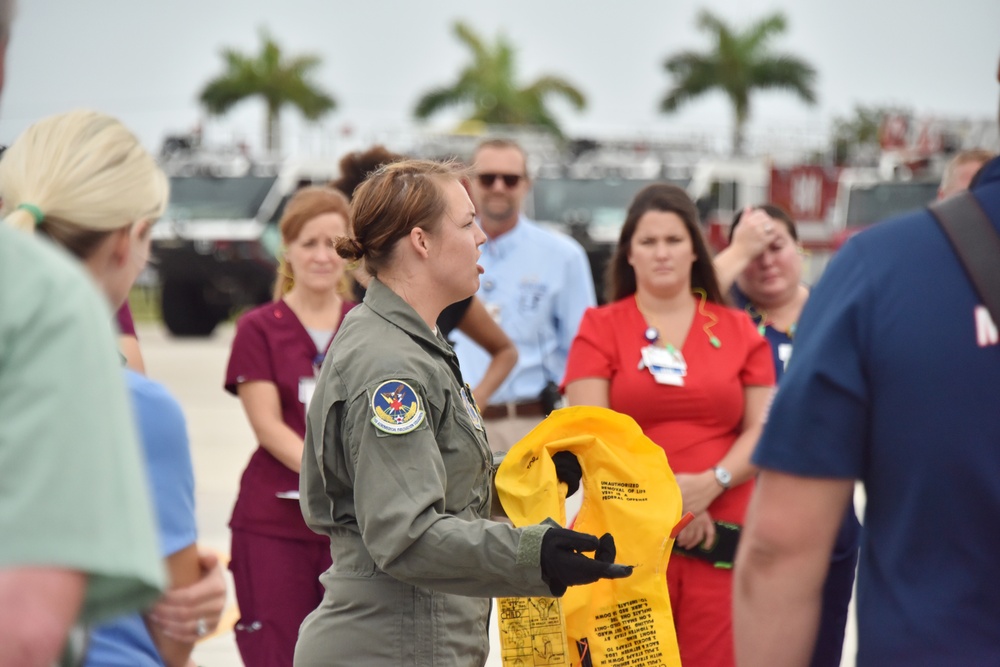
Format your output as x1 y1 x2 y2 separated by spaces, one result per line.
295 161 631 667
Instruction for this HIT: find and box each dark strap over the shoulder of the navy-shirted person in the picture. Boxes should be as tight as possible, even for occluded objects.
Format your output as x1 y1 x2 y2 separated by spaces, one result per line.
929 190 1000 324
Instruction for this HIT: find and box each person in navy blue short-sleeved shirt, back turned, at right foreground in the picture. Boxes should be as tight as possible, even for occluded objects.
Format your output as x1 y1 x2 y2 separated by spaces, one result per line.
734 60 1000 667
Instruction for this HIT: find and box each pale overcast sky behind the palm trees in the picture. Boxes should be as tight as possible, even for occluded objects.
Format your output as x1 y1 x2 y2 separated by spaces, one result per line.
0 0 1000 151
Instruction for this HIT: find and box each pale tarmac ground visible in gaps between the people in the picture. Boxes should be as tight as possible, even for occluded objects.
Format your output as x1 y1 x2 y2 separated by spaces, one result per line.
138 324 856 667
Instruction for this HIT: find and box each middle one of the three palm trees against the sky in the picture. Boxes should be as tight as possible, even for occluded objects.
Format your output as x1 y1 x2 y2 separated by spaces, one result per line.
413 21 587 136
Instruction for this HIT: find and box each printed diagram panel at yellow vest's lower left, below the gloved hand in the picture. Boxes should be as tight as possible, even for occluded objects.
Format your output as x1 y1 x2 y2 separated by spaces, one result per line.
497 598 570 667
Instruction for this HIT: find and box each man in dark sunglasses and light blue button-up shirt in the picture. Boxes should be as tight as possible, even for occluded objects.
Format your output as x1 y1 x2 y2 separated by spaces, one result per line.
454 139 596 451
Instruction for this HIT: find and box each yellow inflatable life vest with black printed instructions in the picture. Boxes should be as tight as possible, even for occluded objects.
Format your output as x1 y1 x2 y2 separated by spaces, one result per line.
496 407 681 667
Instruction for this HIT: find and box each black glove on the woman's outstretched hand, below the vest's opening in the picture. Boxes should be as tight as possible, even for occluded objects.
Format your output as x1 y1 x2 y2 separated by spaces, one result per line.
542 528 632 597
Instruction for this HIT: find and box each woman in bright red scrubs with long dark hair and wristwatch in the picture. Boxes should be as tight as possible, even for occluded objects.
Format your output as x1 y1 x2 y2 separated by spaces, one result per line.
564 184 774 667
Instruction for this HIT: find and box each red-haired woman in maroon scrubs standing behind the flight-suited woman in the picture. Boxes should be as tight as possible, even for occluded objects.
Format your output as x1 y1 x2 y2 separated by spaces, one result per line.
225 187 355 667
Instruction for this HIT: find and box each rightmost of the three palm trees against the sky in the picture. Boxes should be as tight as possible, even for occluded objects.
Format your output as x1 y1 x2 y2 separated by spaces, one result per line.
660 10 816 154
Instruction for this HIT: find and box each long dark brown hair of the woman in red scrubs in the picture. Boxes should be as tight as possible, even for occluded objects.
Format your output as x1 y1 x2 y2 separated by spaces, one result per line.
606 183 725 303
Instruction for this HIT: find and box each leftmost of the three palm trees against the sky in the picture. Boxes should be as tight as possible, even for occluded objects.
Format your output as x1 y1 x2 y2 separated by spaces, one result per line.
199 29 337 151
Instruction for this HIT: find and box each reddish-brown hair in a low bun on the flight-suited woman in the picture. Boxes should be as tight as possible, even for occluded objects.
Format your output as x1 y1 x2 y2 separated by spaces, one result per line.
337 160 466 276
